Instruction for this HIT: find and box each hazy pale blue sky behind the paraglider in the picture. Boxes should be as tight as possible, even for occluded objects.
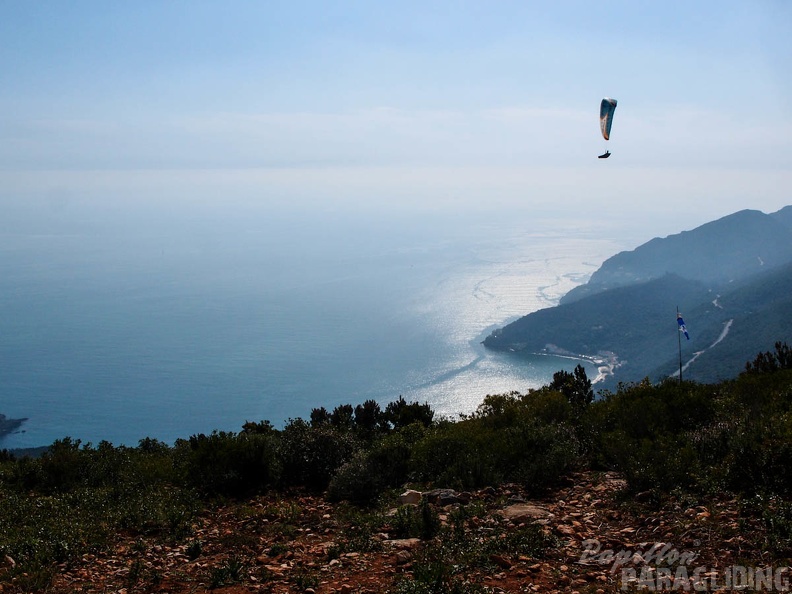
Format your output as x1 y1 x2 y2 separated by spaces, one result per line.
0 0 792 232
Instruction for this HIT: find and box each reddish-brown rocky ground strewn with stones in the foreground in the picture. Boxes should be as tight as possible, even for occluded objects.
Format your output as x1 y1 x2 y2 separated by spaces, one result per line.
9 473 792 594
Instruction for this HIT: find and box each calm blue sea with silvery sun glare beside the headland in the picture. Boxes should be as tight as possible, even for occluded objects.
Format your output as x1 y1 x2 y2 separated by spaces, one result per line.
0 201 622 447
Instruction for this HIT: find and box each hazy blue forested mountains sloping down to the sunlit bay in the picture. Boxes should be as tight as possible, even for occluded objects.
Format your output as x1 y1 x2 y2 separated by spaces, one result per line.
484 206 792 388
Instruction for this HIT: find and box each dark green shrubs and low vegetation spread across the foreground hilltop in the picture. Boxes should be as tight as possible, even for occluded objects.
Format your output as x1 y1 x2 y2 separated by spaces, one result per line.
0 343 792 593
